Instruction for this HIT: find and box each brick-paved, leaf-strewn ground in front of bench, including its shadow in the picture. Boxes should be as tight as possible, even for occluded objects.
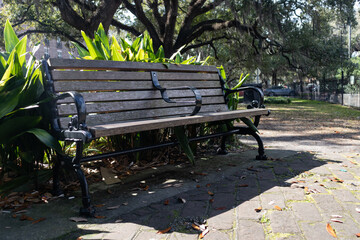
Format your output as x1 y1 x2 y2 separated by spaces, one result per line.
0 108 360 240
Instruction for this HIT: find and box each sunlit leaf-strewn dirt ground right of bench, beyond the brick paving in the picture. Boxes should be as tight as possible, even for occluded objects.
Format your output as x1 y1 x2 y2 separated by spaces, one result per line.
245 102 360 154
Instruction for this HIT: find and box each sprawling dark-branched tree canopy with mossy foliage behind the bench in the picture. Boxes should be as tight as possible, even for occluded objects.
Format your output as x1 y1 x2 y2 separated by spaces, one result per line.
0 0 356 84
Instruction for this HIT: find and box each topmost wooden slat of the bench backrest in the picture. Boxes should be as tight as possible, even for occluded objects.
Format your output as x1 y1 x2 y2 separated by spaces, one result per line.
48 58 218 73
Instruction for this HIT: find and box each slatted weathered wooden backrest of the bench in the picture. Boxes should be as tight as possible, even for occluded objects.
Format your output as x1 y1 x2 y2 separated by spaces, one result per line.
48 59 228 128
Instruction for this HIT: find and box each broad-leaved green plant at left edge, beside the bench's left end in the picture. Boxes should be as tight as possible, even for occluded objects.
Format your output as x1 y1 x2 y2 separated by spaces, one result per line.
0 21 61 186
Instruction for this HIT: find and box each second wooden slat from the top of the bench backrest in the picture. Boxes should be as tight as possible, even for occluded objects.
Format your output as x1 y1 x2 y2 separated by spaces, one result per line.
52 71 219 81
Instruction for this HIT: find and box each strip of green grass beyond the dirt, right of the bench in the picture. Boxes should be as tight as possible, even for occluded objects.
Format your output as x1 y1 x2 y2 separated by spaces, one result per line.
267 98 360 121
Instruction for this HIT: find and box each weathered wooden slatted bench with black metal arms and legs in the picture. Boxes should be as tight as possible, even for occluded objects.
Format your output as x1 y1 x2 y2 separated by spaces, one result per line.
43 59 269 215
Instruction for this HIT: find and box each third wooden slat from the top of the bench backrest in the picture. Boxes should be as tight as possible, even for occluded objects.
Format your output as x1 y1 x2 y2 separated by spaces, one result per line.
54 81 220 92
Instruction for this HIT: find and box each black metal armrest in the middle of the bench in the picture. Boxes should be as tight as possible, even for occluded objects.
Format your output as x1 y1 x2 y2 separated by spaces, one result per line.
151 72 202 116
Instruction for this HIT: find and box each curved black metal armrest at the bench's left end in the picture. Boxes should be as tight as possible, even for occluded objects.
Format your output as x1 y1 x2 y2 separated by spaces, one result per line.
55 92 87 130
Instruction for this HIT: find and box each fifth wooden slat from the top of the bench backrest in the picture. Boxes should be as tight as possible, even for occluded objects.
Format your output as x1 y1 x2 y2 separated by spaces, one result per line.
58 97 224 116
